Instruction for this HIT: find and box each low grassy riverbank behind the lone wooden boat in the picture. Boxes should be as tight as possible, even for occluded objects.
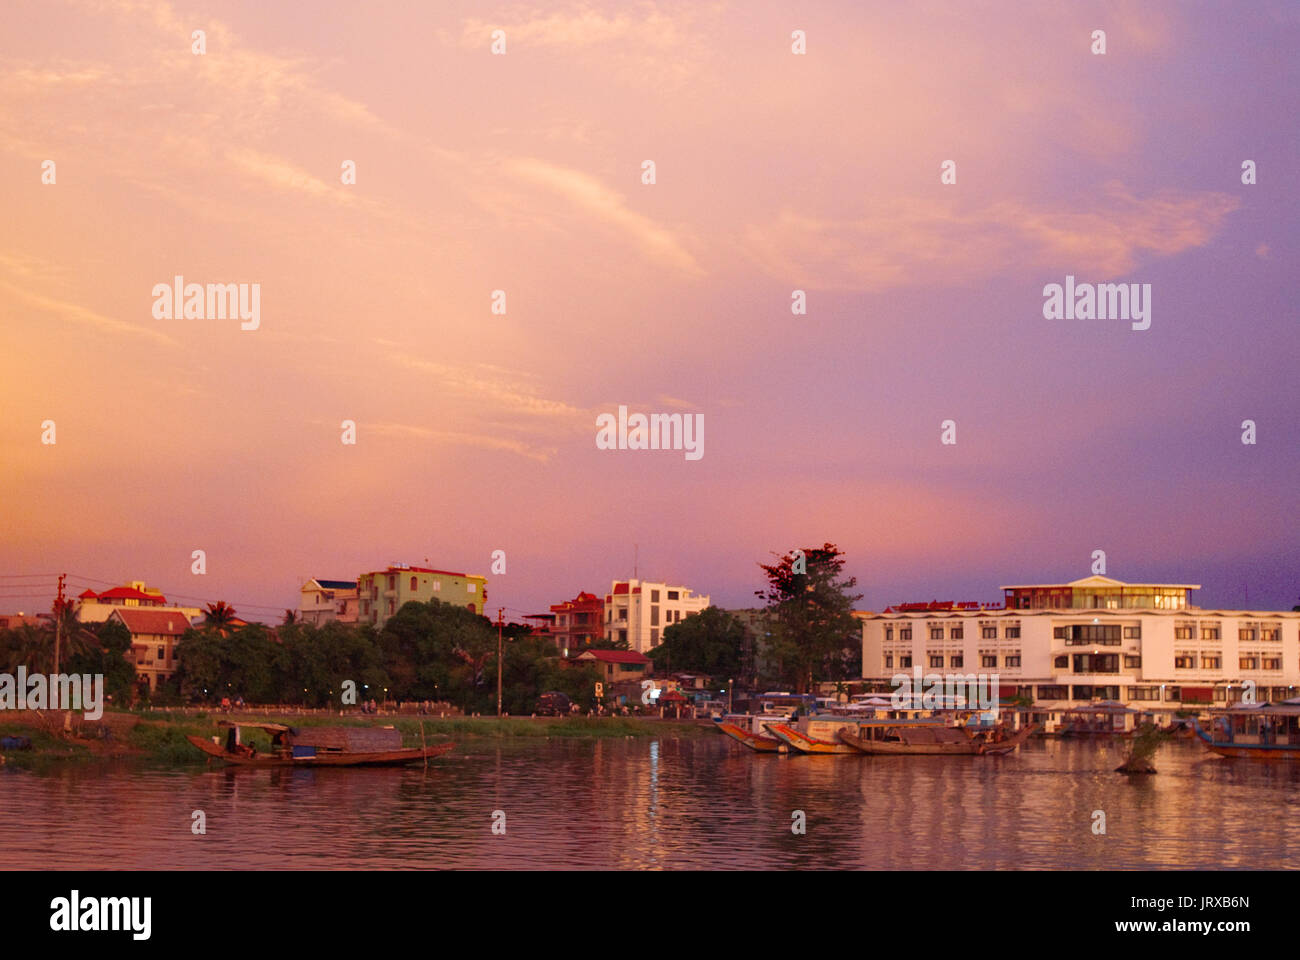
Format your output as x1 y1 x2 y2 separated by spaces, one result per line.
0 710 714 766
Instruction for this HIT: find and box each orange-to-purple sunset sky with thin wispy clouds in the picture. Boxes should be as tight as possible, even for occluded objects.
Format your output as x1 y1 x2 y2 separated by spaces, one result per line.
0 0 1300 620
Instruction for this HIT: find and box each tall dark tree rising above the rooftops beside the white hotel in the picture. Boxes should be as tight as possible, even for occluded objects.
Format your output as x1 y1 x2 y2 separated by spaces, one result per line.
755 542 862 693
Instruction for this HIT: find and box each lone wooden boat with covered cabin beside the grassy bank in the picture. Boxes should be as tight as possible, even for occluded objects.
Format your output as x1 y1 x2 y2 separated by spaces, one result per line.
185 721 455 766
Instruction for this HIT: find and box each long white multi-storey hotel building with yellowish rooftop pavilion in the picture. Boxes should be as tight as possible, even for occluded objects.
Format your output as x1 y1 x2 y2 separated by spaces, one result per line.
862 576 1300 710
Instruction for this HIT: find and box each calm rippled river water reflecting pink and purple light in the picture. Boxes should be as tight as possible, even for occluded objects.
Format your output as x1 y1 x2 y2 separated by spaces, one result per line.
0 736 1300 870
